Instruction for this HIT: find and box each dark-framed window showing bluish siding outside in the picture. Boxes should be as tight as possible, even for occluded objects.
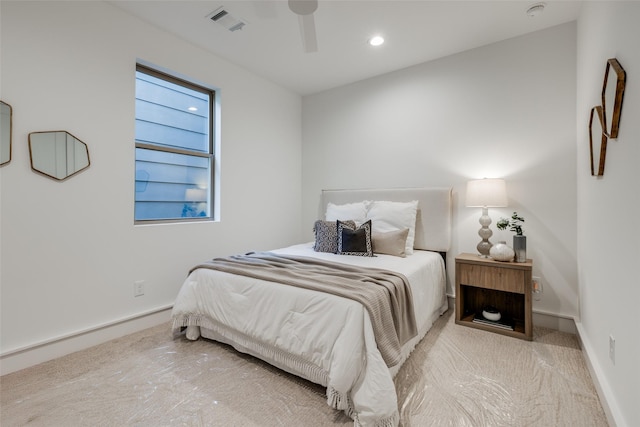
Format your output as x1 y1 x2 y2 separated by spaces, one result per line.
134 65 215 222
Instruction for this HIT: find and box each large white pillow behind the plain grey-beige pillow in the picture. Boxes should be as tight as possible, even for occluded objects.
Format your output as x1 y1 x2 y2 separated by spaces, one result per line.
366 200 418 255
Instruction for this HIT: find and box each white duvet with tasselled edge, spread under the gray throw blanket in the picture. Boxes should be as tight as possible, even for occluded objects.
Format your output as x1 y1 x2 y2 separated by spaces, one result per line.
172 243 447 426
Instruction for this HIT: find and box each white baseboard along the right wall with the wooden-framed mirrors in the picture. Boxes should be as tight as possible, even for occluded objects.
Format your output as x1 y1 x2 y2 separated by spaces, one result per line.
576 321 627 427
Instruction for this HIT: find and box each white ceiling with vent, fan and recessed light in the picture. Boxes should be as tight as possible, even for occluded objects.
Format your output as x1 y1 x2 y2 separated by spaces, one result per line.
110 0 581 95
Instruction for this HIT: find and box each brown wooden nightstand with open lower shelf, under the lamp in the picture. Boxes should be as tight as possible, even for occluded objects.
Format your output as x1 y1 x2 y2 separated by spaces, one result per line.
456 254 533 341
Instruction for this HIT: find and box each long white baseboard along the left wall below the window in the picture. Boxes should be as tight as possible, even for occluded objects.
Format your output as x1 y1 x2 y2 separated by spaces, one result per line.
0 305 172 375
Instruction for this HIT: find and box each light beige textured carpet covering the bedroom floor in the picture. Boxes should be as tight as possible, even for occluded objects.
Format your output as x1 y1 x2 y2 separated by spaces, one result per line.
0 310 607 427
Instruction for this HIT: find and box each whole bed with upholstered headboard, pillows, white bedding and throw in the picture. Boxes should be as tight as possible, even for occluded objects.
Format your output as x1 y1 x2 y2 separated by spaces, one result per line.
172 188 451 426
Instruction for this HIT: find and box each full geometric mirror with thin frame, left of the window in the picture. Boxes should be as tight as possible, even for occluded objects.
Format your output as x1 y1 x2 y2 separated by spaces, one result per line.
29 131 90 181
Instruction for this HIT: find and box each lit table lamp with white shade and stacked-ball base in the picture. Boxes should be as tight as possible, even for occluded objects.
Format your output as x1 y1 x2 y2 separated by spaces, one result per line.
466 178 507 258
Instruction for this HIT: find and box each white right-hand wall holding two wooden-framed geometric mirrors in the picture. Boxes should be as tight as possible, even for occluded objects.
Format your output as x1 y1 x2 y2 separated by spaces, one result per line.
577 2 640 426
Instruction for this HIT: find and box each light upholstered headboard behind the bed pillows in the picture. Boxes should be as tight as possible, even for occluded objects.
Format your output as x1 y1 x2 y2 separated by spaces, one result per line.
321 187 451 252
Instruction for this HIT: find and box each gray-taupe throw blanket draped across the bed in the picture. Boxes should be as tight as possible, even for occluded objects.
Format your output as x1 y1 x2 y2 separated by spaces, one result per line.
191 252 417 367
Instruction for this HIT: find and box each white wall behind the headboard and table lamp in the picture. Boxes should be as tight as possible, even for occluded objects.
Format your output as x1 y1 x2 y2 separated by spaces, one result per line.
303 23 578 317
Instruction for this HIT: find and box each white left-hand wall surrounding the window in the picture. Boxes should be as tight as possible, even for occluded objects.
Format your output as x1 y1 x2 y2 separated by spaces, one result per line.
0 1 301 373
